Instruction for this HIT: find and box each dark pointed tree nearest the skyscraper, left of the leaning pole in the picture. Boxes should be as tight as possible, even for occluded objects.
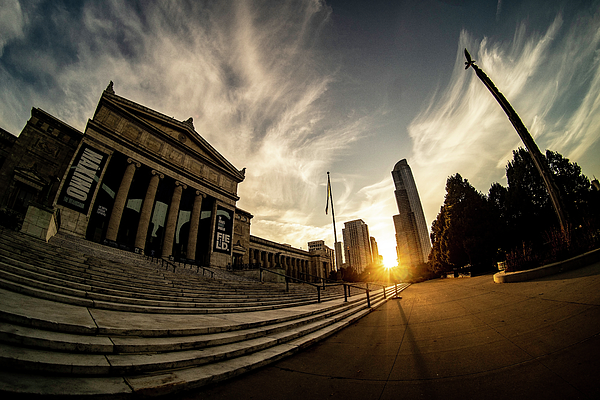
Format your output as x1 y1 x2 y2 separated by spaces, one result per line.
429 174 498 273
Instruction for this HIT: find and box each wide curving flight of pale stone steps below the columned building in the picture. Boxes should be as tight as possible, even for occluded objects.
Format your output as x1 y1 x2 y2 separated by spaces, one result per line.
0 230 407 398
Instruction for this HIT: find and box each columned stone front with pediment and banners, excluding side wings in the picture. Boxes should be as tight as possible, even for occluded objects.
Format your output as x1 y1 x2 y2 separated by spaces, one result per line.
49 84 244 267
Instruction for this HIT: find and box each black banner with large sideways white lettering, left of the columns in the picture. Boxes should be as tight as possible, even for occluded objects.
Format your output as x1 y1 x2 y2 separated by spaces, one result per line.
58 144 108 214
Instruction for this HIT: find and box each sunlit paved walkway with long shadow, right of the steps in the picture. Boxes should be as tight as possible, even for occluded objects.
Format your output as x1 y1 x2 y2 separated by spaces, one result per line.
179 263 600 400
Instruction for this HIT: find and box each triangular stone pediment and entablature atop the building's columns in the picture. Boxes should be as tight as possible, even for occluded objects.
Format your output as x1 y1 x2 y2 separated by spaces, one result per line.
94 92 244 184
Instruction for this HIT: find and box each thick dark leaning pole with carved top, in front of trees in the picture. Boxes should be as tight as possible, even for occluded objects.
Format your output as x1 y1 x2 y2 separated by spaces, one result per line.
465 49 567 232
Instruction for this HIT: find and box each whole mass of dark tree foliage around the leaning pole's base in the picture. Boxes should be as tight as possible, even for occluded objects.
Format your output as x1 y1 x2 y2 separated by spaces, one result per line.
429 148 600 273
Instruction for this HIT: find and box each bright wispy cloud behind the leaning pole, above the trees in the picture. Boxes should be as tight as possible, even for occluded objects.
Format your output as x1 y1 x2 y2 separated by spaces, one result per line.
408 9 600 227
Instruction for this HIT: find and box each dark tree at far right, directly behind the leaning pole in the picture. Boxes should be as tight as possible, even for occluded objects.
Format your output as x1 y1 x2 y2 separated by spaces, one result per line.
488 148 600 268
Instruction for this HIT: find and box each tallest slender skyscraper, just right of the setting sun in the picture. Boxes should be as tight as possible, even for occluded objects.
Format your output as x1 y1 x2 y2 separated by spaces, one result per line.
392 159 431 267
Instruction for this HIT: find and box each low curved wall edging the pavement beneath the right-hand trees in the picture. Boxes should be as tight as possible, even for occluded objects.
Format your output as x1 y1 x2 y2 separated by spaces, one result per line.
494 249 600 283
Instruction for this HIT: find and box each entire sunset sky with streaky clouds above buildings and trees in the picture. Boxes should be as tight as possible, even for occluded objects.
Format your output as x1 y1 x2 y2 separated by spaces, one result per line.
0 0 600 266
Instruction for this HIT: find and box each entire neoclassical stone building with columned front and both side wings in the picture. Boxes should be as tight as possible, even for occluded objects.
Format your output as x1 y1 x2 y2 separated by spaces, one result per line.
0 82 332 277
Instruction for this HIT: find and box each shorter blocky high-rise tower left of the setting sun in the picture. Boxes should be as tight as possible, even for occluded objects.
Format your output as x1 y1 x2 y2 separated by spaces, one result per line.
342 219 373 274
